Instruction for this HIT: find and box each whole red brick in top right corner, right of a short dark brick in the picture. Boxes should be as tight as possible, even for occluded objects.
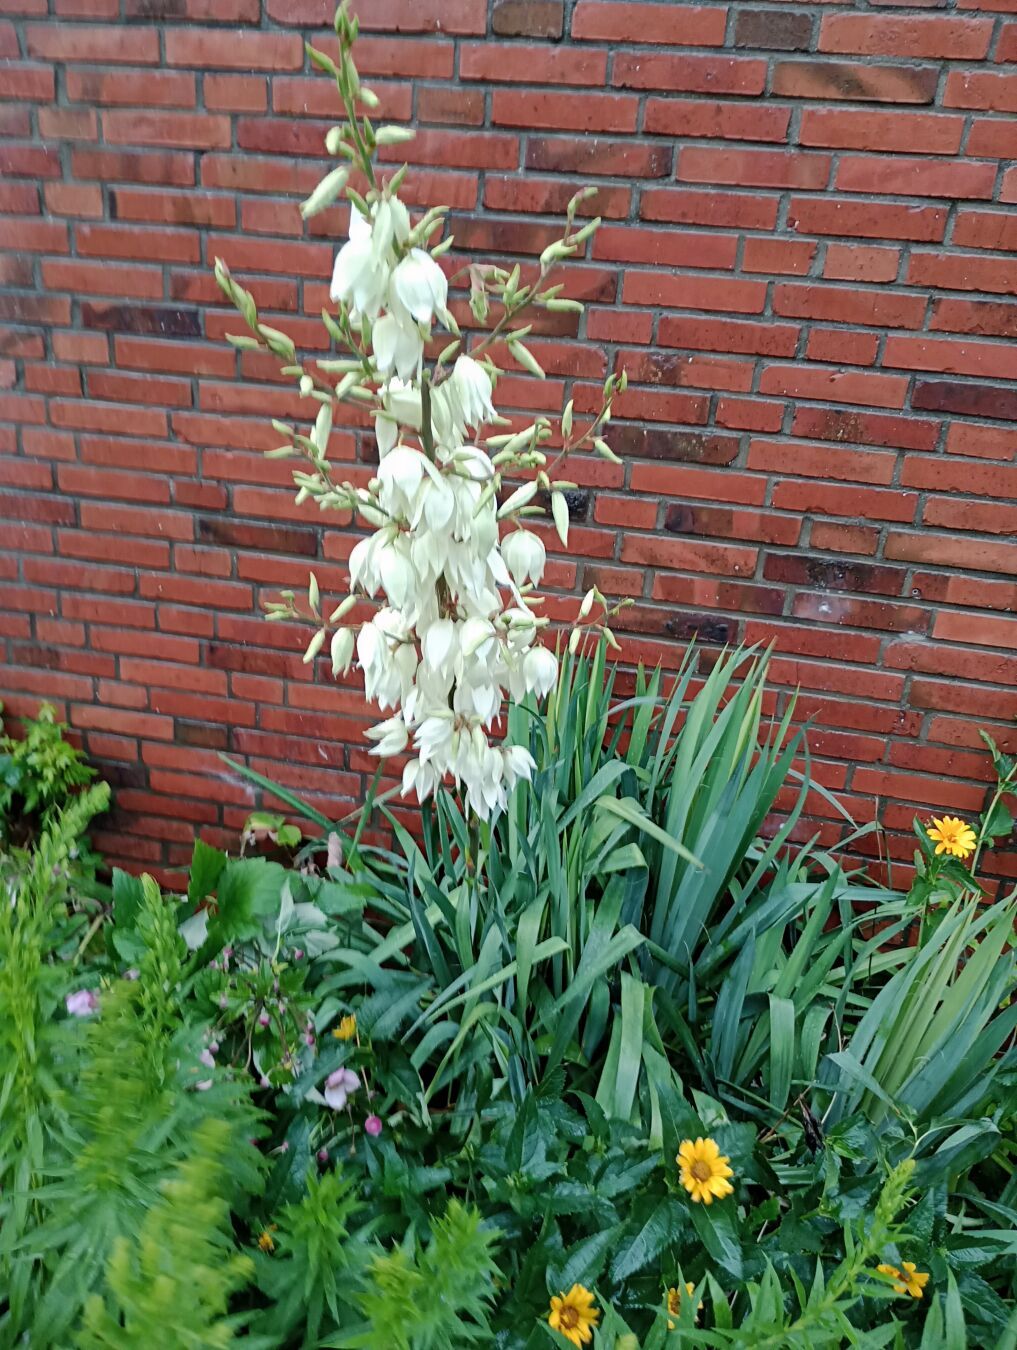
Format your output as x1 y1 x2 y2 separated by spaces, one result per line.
818 14 993 61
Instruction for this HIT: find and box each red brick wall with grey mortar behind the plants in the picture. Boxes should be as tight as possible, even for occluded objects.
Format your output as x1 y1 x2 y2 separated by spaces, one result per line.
0 0 1017 865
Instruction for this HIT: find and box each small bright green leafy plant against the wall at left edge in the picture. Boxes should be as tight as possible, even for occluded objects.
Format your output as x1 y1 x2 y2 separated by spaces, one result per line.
0 703 96 834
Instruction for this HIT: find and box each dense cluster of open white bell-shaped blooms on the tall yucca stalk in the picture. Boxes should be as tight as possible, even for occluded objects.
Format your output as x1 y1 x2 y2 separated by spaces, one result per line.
322 184 558 819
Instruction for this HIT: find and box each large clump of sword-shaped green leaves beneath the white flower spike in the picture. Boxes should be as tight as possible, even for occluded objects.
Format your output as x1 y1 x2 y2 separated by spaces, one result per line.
311 645 885 1139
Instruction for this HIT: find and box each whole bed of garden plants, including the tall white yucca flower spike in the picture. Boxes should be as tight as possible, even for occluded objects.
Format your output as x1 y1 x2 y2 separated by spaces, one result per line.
0 8 1017 1350
